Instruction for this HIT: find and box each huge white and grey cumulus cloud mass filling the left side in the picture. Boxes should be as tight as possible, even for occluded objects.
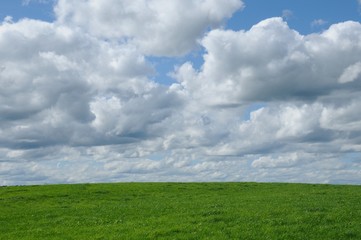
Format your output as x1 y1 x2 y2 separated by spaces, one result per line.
0 17 179 150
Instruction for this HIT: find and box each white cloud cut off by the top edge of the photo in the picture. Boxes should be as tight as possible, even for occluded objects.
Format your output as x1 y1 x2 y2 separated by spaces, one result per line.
55 0 243 56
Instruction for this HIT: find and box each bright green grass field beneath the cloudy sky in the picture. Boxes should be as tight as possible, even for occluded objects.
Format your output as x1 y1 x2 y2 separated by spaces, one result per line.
0 183 361 240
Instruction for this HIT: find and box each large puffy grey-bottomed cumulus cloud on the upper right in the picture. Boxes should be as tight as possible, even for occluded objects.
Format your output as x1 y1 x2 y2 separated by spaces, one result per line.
175 18 361 105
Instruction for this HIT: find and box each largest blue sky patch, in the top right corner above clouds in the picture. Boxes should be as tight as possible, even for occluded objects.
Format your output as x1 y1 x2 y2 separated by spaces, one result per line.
226 0 361 34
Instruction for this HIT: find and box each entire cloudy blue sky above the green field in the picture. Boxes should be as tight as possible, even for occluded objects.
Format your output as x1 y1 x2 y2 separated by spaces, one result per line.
0 0 361 185
